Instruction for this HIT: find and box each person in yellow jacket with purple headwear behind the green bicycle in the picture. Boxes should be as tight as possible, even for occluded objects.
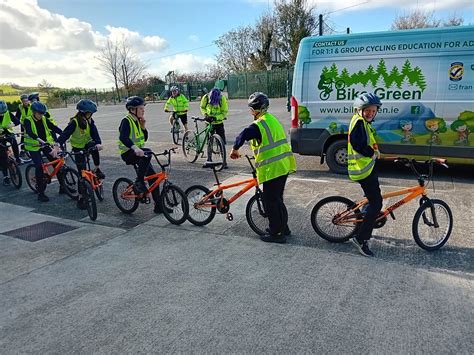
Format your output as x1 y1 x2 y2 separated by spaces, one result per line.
200 88 229 144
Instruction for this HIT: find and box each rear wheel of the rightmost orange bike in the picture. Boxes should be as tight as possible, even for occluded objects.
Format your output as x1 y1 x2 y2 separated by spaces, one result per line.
311 196 360 243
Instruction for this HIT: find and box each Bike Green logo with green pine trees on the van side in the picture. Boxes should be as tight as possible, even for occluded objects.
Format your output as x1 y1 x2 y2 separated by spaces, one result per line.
318 59 426 101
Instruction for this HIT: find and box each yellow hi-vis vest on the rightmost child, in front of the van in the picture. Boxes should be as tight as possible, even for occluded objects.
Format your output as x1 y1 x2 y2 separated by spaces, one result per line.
347 114 377 181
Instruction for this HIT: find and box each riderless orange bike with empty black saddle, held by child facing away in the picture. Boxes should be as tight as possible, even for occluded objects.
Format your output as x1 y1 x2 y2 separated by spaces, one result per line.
182 155 278 235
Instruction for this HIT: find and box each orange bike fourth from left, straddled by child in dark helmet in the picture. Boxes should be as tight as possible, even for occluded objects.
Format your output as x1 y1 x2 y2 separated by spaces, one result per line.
112 148 189 224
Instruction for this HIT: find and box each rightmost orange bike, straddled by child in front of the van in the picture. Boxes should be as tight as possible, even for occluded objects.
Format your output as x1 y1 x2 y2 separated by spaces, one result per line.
311 158 453 251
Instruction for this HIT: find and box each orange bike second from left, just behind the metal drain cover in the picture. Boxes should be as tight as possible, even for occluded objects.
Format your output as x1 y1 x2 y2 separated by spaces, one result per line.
25 143 79 200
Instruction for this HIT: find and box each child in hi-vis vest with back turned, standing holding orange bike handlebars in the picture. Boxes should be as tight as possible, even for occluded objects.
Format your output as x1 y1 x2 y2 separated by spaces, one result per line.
230 92 296 243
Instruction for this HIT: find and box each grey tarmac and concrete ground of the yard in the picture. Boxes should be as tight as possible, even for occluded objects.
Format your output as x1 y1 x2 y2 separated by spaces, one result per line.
0 100 474 354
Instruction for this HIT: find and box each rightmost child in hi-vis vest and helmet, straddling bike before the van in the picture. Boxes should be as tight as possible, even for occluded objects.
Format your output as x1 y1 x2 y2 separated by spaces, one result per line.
347 93 382 256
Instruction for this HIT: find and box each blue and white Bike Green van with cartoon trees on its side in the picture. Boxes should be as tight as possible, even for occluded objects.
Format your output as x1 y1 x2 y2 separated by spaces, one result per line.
290 26 474 173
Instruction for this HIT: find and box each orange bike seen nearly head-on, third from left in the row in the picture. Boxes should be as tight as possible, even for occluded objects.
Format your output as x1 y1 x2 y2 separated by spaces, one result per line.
71 146 104 221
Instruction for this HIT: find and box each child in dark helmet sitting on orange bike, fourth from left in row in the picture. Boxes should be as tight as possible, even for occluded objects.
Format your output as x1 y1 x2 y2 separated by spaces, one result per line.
118 96 167 213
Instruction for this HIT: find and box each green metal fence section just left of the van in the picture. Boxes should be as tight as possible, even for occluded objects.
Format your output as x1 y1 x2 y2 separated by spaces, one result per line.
227 67 293 99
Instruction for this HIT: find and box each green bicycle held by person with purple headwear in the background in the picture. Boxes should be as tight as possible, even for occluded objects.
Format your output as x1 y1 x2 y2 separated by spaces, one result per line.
182 117 226 171
